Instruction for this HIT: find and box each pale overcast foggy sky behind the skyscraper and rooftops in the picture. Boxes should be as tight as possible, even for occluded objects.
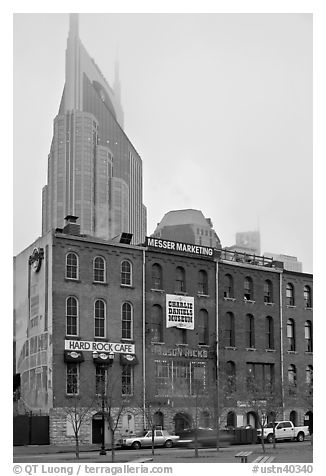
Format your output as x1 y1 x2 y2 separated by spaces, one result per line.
13 13 313 272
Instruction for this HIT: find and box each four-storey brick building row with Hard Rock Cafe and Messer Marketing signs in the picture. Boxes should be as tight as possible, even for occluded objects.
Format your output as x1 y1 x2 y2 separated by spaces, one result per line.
14 221 313 444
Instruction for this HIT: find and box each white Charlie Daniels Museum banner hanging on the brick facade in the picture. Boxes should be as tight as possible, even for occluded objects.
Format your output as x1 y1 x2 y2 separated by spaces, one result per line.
166 294 194 329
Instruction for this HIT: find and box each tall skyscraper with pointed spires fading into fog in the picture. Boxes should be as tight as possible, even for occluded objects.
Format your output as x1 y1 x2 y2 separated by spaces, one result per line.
42 14 146 243
